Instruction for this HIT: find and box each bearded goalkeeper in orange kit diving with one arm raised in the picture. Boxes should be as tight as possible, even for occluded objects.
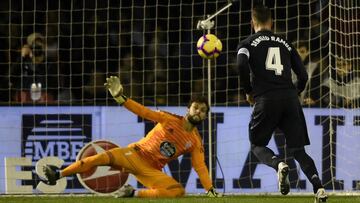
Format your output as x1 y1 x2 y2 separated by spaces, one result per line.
44 76 220 198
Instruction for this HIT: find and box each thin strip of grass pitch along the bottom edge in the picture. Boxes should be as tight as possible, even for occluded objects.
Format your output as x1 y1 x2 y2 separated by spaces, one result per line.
0 195 360 203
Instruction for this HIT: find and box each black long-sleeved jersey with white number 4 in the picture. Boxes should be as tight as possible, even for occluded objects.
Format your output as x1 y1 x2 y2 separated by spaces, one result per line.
237 30 308 98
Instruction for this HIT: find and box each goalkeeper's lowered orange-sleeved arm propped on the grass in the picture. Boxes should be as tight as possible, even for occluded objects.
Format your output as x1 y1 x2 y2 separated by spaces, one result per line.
191 135 221 197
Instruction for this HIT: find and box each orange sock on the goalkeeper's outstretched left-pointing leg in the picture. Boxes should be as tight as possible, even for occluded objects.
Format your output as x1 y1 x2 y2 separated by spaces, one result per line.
61 152 110 177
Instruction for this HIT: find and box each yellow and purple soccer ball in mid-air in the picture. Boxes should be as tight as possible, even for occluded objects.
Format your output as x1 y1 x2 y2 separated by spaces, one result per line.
196 34 222 59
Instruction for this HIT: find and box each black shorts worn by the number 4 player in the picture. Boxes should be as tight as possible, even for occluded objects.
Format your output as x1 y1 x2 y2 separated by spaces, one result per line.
249 91 310 148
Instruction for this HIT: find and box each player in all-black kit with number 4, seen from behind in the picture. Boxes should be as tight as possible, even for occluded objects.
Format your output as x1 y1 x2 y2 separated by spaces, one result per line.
237 5 327 203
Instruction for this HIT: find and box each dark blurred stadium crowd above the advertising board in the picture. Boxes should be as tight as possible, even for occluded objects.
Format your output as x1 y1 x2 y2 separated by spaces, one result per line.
0 0 360 108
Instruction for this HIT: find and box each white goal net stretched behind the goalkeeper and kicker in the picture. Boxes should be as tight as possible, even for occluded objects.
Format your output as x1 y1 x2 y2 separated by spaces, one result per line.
0 0 360 193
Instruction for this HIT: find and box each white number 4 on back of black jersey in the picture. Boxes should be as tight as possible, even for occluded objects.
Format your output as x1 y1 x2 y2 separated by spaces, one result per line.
265 47 283 75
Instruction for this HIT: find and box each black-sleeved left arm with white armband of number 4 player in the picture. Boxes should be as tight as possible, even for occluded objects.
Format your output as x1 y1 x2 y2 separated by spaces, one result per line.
237 47 254 104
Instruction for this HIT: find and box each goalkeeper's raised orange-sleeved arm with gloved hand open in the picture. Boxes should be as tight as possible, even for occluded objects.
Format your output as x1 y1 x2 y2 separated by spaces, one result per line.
104 76 165 123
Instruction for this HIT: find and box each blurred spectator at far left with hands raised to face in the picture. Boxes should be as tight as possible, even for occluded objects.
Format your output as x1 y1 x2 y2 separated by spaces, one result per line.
10 33 58 103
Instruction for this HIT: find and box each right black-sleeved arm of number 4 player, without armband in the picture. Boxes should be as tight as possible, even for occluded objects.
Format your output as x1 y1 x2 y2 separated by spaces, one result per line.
290 47 308 93
